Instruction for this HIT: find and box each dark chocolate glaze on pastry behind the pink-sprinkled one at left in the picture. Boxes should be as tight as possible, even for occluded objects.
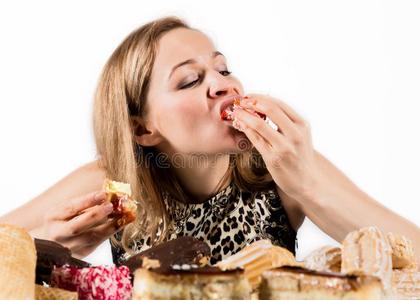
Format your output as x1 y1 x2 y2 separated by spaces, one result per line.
35 239 90 284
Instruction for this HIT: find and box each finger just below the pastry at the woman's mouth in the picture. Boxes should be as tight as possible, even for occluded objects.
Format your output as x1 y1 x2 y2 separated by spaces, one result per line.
234 109 287 154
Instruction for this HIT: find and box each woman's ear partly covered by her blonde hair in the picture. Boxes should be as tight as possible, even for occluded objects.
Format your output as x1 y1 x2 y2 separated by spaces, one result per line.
130 116 164 147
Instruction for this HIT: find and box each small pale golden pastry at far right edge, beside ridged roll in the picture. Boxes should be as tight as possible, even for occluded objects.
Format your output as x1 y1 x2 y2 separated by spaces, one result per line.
387 232 417 269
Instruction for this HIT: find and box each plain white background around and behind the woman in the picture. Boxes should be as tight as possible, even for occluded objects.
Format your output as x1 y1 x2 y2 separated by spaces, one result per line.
0 0 420 263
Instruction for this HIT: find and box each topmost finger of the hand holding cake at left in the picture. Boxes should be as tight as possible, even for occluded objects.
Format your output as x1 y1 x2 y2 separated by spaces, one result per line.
51 191 105 220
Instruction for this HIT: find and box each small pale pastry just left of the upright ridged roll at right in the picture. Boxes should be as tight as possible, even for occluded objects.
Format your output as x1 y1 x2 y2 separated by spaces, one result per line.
304 246 341 273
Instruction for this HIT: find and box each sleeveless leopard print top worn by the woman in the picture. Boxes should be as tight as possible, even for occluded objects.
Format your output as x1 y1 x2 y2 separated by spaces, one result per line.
111 181 297 265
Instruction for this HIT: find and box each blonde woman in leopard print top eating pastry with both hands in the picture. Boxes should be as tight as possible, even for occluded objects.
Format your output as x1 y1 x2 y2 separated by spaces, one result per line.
0 17 420 263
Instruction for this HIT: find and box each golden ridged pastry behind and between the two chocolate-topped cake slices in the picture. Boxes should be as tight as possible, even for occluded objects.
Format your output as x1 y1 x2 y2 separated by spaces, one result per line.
217 240 297 289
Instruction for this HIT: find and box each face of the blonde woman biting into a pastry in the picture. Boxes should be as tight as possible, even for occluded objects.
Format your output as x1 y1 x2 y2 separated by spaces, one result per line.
146 28 249 154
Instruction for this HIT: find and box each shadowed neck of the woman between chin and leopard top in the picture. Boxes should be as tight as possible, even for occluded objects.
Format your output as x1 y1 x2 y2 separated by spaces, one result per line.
168 154 233 203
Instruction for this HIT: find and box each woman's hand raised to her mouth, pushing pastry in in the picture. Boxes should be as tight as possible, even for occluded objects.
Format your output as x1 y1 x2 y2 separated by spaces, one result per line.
234 94 320 199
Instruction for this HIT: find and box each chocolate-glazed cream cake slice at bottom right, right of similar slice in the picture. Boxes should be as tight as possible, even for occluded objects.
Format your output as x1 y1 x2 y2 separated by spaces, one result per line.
259 266 384 300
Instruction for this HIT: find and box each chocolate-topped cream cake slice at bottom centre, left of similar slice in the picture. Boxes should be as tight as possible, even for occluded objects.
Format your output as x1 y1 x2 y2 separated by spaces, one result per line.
133 264 251 300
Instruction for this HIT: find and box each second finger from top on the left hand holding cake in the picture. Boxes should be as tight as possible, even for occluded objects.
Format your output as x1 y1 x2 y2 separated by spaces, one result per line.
67 202 113 236
